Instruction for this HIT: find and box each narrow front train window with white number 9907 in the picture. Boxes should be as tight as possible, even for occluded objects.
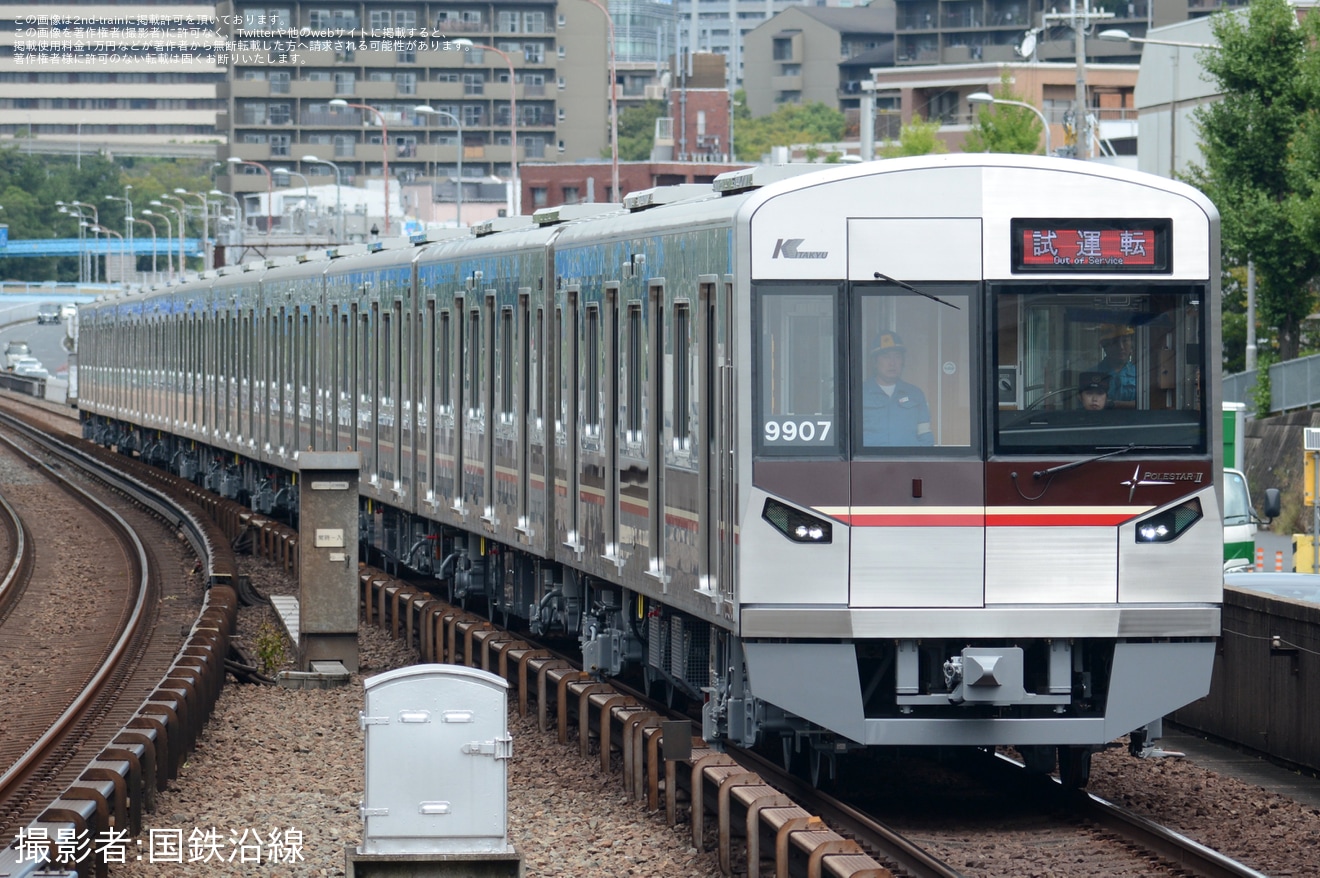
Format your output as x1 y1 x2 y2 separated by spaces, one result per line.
752 284 842 457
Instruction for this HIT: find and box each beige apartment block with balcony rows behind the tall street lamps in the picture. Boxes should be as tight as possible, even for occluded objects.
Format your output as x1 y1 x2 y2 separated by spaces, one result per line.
219 0 610 215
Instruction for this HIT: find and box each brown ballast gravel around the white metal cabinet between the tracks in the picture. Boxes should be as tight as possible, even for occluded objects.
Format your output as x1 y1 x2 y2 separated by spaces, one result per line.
110 558 719 878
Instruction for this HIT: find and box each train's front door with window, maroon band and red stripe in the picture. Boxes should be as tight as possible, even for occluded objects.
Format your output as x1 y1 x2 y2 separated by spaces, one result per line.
846 219 985 607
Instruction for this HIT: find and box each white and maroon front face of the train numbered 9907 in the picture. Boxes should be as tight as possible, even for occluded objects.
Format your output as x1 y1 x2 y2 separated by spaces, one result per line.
728 156 1222 784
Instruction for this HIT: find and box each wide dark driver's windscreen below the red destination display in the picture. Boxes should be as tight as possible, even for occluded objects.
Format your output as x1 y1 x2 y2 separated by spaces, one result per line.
991 283 1208 454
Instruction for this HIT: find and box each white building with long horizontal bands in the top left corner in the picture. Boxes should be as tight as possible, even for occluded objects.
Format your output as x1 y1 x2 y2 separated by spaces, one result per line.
0 0 224 156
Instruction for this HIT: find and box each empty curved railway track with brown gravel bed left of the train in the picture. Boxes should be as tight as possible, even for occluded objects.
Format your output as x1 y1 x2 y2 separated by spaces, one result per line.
0 400 236 875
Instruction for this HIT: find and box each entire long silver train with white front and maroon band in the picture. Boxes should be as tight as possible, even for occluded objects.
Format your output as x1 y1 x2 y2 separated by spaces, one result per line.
79 154 1222 784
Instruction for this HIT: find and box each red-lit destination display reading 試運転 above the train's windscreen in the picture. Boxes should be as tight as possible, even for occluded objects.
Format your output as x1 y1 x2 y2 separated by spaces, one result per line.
1012 219 1173 273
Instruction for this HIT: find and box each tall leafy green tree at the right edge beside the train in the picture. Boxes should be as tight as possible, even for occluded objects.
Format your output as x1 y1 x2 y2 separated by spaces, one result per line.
1187 0 1320 359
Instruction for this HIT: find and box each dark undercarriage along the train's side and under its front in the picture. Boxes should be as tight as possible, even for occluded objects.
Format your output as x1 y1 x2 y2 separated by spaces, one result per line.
84 417 1198 786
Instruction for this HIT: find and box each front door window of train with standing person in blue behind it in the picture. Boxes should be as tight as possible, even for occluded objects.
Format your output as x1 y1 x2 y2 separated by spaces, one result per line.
850 283 977 457
